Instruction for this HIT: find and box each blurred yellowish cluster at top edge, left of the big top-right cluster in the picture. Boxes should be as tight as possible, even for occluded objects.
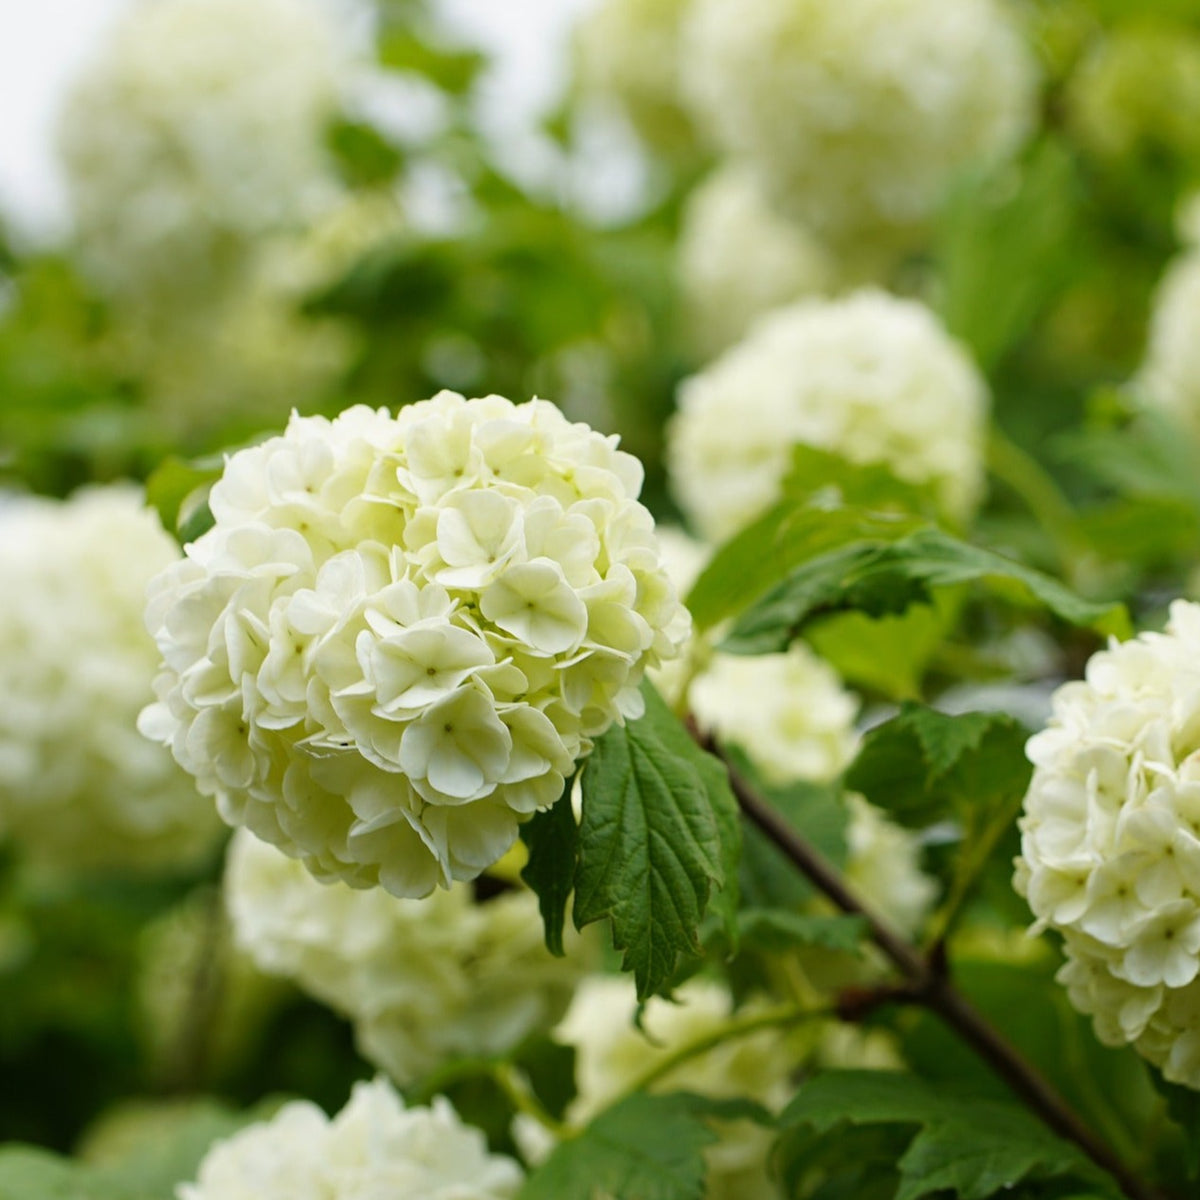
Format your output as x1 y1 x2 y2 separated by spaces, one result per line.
575 0 694 151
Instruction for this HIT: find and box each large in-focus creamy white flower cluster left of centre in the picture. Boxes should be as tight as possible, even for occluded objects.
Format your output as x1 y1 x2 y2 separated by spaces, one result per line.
142 392 689 896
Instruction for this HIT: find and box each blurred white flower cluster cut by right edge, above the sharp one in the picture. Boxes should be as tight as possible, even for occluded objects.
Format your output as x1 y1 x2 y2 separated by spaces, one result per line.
1135 248 1200 433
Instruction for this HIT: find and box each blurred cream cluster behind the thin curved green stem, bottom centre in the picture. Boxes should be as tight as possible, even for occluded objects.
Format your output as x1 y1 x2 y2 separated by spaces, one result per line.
554 976 794 1200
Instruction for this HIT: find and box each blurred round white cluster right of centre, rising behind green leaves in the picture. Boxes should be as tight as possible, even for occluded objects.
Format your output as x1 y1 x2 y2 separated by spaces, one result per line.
667 289 989 541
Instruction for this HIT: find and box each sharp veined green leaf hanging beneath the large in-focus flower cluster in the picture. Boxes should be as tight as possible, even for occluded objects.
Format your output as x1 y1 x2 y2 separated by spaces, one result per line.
574 684 736 1000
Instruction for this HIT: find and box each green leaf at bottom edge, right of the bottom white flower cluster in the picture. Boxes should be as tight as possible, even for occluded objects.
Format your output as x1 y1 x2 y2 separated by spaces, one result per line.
517 1092 769 1200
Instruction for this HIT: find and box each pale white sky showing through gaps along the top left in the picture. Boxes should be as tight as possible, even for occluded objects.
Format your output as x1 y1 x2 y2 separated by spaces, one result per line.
0 0 604 241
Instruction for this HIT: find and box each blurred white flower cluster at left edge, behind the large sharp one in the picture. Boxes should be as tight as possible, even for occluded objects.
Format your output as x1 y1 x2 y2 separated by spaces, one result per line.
0 486 221 869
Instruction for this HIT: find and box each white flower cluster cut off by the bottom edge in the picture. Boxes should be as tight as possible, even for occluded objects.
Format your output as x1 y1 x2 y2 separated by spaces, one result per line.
175 1079 523 1200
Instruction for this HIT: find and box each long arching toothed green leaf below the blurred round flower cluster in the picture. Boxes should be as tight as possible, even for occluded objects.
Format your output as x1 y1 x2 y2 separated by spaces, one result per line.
724 526 1129 654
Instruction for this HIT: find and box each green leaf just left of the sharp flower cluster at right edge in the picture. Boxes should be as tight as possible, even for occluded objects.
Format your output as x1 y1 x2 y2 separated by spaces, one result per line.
846 703 1033 829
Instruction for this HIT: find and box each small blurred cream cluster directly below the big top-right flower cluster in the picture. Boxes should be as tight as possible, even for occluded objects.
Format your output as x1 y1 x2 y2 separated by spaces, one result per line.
676 163 835 353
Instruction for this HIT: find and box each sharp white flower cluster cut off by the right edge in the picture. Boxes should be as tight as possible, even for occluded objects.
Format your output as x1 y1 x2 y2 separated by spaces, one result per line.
1014 600 1200 1088
